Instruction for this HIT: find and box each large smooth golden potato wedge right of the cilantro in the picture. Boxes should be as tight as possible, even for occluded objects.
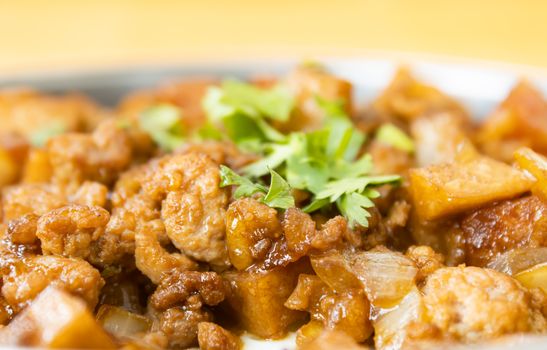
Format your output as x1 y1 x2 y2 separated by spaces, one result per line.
410 157 533 220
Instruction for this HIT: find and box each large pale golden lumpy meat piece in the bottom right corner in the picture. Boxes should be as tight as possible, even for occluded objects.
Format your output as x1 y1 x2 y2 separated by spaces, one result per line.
408 266 547 343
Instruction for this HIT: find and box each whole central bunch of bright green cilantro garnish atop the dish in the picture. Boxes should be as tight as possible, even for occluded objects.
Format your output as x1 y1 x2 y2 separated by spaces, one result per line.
210 76 402 227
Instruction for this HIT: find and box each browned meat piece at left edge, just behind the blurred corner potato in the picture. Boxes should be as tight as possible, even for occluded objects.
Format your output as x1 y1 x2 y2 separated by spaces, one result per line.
0 251 104 312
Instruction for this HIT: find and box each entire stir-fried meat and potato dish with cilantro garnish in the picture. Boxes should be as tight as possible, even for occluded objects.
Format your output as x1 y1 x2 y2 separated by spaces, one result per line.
0 64 547 350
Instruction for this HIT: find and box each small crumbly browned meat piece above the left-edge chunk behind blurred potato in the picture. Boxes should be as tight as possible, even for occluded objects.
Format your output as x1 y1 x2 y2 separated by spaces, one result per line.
36 204 110 261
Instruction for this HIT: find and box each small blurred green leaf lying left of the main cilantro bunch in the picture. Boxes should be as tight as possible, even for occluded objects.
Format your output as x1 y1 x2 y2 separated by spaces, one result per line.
139 104 185 152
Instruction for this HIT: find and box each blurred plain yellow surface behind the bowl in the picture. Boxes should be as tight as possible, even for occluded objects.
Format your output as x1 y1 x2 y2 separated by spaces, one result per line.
0 0 547 75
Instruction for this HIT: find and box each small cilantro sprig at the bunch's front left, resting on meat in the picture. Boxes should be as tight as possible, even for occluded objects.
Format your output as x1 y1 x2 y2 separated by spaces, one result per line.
220 165 295 209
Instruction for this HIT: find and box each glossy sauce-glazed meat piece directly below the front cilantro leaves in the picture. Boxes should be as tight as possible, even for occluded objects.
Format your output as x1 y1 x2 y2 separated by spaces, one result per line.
226 198 346 270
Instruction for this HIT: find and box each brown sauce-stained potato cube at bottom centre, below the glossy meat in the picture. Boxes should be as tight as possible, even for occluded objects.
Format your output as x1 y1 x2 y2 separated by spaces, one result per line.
223 261 309 338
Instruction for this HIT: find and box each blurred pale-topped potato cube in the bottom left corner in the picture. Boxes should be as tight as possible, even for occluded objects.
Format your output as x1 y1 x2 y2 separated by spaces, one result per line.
0 287 115 349
